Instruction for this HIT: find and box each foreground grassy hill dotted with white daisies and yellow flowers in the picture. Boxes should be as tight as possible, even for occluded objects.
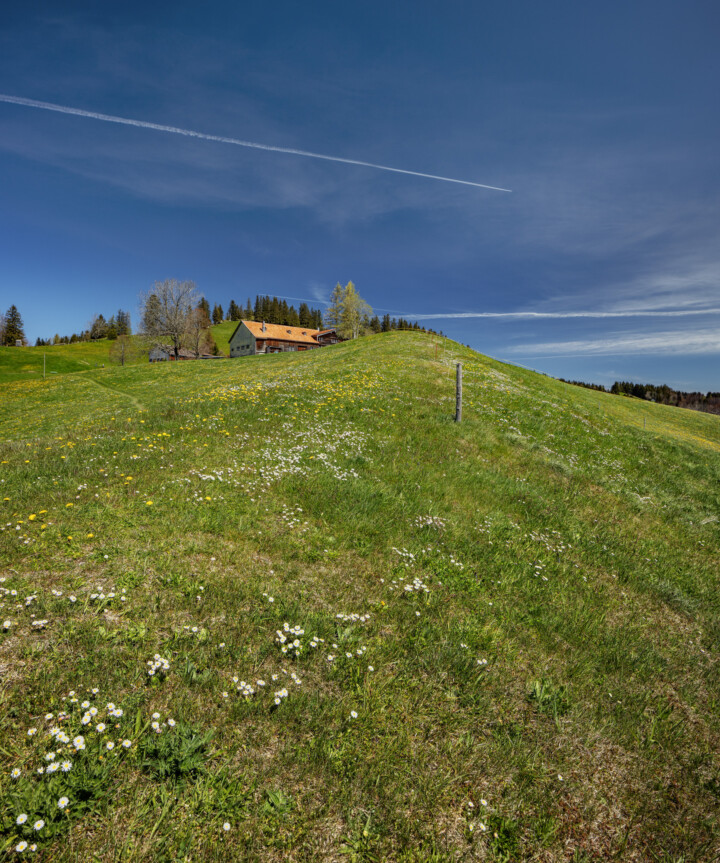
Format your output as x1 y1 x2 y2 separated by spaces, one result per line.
0 333 720 863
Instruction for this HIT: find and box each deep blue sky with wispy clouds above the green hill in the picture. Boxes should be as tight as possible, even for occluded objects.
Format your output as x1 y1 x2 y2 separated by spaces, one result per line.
0 0 720 390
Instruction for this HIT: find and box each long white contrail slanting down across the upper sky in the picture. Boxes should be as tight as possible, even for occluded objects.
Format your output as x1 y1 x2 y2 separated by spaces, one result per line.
0 93 512 192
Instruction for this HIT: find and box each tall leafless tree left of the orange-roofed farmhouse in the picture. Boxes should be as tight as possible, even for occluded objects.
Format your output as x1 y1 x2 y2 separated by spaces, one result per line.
141 279 200 360
